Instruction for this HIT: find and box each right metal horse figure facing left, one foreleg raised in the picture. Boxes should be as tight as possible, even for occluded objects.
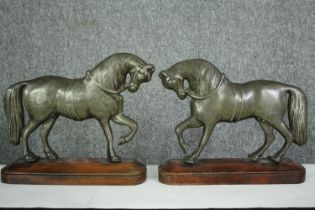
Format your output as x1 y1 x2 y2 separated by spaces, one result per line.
159 59 307 164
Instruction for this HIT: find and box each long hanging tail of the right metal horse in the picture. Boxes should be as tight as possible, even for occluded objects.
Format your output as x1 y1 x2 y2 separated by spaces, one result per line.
288 87 307 146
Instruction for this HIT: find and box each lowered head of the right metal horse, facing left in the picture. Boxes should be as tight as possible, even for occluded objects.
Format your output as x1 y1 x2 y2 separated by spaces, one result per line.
159 70 187 100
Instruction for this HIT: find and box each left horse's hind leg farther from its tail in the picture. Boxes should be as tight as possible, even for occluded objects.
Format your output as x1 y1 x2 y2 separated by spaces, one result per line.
40 115 58 160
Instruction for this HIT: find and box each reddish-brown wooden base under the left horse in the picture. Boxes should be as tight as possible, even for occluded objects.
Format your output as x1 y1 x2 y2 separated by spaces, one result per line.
1 159 146 185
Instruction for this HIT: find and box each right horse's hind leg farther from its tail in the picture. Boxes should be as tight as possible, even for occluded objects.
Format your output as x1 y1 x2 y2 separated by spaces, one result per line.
248 120 275 162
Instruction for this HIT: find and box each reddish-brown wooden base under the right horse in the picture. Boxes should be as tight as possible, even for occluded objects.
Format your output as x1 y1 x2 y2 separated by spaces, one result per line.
159 159 305 185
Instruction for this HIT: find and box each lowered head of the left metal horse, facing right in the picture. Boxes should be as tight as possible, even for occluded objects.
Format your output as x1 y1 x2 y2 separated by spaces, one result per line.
127 64 155 93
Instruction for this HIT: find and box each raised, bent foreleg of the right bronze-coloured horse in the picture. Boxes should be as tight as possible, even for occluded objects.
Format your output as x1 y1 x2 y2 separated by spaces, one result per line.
175 117 202 154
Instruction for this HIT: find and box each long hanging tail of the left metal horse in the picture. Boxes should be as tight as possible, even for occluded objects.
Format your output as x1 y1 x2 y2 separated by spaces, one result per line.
4 82 27 145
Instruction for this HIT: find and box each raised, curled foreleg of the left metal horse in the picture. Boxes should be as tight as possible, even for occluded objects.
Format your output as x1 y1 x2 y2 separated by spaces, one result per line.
112 113 138 145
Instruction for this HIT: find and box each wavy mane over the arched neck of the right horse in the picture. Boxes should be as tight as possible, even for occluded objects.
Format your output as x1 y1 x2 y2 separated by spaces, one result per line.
171 59 224 95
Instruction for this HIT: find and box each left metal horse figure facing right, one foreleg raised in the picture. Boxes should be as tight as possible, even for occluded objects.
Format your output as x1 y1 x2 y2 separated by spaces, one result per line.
4 53 154 162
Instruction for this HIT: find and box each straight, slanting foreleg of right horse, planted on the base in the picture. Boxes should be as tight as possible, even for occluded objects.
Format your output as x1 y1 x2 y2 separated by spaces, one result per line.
184 124 215 164
